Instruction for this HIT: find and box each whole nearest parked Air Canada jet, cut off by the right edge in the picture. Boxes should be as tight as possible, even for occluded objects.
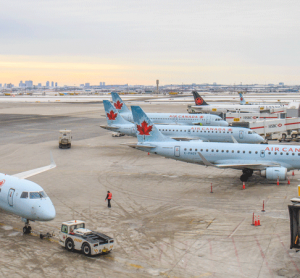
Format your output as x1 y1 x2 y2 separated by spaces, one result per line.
126 106 300 182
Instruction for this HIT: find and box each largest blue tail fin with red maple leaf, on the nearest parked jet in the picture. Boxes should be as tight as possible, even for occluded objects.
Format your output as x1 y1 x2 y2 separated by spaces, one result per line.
131 106 174 142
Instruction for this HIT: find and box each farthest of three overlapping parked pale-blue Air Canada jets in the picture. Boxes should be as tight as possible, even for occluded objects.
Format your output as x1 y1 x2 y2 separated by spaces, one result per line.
111 92 228 126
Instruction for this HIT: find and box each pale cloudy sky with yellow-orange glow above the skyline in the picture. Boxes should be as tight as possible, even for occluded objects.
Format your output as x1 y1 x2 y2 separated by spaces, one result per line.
0 0 300 85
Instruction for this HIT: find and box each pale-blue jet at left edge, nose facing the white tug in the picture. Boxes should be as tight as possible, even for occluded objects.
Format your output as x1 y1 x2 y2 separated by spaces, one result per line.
0 155 56 234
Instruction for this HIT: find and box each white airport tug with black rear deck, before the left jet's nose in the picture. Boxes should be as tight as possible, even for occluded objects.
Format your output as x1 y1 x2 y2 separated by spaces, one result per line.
59 220 114 256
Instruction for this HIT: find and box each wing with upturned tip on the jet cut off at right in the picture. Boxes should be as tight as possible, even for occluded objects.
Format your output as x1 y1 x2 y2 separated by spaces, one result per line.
198 152 281 170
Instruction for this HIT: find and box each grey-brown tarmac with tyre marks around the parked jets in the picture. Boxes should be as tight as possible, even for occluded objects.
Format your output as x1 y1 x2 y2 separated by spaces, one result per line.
0 102 300 278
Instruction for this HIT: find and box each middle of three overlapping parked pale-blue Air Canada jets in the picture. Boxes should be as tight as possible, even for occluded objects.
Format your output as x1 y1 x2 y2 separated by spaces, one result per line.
100 100 264 144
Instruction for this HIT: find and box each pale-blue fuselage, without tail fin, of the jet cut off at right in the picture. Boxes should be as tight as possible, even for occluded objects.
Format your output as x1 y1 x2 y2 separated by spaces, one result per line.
137 141 300 170
